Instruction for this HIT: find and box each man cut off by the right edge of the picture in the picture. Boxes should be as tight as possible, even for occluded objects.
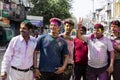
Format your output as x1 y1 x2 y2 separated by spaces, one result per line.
109 20 120 80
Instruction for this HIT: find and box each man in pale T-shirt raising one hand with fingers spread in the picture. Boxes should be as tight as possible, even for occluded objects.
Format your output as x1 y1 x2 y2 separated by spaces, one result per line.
77 20 114 80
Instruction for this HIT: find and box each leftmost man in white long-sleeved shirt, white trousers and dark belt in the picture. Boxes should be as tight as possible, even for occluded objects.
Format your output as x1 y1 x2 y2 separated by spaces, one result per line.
1 21 37 80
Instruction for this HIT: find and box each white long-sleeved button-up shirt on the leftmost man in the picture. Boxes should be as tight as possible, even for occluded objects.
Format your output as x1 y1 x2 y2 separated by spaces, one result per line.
1 35 37 72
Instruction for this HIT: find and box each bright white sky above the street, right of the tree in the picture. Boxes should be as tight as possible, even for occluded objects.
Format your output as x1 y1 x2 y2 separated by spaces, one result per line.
71 0 105 20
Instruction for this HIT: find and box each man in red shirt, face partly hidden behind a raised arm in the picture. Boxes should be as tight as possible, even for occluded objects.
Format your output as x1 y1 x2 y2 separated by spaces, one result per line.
74 26 88 80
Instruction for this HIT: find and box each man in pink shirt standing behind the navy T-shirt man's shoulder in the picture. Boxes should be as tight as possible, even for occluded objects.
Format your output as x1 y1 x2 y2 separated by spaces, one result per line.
60 19 74 80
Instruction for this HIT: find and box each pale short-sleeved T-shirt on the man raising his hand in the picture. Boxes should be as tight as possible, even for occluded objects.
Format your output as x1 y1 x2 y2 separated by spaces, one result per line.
85 36 114 68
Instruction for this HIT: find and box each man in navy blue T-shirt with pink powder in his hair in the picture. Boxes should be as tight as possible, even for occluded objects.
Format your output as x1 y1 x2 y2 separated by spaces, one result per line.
36 18 68 80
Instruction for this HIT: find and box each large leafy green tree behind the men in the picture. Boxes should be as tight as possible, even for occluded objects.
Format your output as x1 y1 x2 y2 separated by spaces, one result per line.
30 0 72 25
